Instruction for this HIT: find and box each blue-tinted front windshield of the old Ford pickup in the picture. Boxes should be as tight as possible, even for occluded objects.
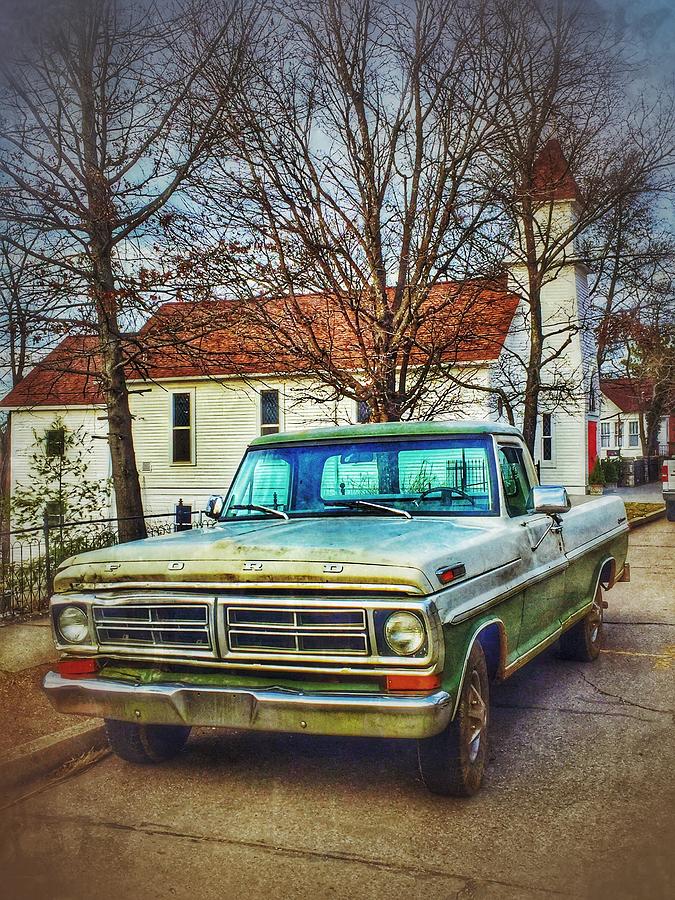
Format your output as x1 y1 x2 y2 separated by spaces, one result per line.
221 437 499 520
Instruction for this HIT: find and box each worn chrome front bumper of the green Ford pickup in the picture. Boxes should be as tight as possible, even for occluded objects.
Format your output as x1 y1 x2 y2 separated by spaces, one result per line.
43 672 452 738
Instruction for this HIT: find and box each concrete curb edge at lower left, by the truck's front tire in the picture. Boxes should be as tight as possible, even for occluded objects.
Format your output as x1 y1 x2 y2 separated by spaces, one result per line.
0 719 108 787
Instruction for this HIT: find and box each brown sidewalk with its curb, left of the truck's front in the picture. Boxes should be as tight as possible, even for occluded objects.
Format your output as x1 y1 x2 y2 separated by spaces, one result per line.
0 616 104 789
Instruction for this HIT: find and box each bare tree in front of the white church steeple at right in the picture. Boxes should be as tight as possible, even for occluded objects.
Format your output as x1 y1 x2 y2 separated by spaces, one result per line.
473 0 675 450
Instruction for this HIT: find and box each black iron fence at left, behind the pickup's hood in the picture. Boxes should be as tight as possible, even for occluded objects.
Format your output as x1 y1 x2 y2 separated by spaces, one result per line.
0 502 201 621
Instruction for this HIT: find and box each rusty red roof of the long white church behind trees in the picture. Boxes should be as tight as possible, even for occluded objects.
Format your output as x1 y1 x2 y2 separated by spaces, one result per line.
0 281 519 408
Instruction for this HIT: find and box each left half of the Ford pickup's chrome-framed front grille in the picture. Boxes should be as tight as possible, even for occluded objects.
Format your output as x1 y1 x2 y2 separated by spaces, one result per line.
93 603 211 650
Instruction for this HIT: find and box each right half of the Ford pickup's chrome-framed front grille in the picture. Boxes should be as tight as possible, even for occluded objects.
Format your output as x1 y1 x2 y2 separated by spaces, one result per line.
225 606 369 656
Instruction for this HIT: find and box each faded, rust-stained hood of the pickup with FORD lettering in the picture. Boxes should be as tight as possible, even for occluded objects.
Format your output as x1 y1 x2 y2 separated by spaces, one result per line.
55 514 508 594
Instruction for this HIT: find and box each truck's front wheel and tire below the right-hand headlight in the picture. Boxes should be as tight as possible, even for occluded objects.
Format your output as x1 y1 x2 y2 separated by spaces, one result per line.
417 641 490 797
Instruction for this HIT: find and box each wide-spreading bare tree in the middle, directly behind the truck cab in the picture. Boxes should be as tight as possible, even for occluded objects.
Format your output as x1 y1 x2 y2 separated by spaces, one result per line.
178 0 503 421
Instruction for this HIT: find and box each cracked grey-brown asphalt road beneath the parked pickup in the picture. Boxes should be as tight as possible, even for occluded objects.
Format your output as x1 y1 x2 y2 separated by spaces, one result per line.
0 521 675 900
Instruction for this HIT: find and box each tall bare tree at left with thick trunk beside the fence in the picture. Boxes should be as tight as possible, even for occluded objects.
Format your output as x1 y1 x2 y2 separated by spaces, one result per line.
0 0 258 539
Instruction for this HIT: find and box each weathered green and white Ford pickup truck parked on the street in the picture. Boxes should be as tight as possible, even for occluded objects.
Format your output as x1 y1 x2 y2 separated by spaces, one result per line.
44 421 628 795
